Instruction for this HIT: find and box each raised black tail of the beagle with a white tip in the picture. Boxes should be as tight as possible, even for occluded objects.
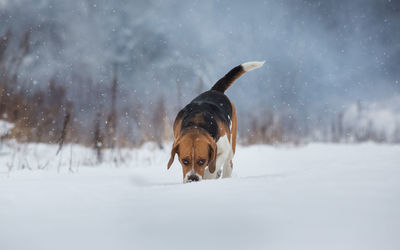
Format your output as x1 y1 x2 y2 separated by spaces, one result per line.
211 61 265 93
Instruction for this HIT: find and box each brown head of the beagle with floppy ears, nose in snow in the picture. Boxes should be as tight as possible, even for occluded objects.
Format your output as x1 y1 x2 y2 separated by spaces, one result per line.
168 128 217 183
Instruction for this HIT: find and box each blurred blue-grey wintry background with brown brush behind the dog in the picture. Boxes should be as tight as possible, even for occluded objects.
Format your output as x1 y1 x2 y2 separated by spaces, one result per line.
0 0 400 149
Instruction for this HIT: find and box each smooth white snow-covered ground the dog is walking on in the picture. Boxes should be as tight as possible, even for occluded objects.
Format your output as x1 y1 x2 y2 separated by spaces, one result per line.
0 143 400 250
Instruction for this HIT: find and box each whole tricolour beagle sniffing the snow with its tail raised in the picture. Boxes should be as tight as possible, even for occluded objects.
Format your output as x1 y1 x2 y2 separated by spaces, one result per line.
168 62 264 183
